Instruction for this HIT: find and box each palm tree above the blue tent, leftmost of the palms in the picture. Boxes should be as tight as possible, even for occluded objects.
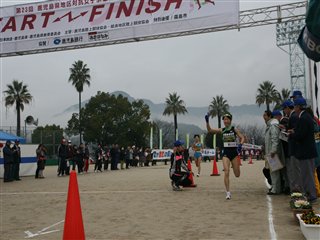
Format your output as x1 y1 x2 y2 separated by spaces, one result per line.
3 80 32 136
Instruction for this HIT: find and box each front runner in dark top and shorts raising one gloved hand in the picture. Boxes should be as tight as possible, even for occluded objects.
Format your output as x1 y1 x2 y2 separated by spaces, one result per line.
205 113 244 200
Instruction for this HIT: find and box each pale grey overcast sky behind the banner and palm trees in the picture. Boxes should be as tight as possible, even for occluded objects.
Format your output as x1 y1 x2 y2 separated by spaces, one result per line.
0 0 308 127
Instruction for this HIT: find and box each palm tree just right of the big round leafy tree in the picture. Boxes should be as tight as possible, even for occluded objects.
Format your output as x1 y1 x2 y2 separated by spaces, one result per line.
163 92 188 140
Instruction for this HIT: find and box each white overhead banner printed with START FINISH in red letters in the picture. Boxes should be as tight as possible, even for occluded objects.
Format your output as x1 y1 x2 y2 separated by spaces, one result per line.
0 0 239 56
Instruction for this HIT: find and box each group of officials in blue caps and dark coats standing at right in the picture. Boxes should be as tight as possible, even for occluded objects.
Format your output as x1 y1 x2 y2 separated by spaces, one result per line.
263 91 320 203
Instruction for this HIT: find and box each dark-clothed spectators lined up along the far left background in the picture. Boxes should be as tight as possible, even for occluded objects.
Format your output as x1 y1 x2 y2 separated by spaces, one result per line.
2 138 156 182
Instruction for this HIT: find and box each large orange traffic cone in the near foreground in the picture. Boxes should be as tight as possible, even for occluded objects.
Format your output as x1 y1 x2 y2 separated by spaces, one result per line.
63 171 85 240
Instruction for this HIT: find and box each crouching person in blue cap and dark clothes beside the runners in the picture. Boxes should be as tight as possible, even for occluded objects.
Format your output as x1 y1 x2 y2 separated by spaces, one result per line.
170 140 192 191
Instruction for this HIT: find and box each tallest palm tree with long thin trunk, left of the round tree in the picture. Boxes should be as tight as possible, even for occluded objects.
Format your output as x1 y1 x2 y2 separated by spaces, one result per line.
69 60 91 143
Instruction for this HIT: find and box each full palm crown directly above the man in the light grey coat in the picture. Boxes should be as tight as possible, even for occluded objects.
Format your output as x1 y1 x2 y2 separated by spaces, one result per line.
256 81 279 110
